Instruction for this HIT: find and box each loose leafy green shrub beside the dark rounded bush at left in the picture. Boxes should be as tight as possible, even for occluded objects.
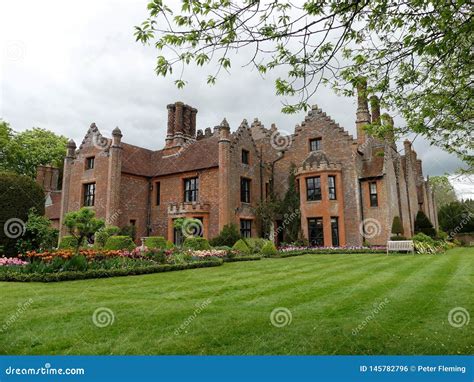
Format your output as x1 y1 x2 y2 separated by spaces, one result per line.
17 208 59 253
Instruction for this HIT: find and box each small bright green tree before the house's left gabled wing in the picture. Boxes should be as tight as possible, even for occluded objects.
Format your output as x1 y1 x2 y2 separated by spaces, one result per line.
64 207 105 252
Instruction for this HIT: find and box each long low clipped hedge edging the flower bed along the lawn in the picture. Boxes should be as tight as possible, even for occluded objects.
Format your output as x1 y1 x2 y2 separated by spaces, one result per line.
0 259 223 283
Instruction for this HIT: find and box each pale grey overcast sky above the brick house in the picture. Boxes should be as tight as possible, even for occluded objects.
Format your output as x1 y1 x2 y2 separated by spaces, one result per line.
0 0 472 194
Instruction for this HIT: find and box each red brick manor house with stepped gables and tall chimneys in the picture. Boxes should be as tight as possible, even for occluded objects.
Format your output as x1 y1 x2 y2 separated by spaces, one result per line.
37 82 437 246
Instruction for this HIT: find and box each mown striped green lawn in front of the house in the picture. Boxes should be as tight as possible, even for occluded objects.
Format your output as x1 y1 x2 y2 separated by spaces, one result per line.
0 248 474 354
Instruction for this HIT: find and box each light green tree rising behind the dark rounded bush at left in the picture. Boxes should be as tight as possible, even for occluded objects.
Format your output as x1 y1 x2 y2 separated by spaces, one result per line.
0 121 67 178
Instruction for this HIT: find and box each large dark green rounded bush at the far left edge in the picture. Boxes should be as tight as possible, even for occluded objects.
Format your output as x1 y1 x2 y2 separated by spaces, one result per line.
0 172 45 256
